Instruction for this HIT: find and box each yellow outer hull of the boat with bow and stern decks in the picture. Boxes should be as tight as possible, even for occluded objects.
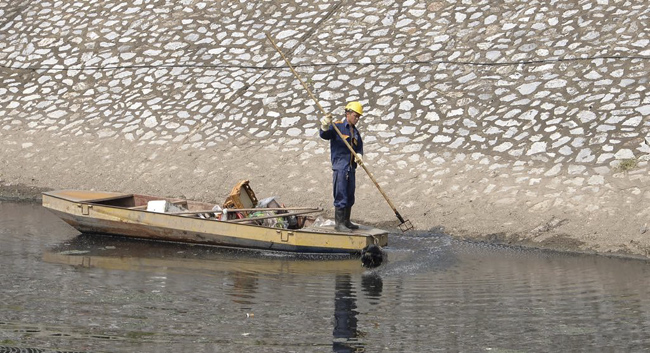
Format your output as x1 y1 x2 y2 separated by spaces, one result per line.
43 190 388 253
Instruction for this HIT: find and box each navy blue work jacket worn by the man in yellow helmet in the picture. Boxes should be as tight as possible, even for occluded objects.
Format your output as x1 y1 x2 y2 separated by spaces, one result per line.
319 119 363 170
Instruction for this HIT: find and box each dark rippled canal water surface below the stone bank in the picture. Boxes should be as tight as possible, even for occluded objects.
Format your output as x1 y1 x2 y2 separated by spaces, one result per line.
0 202 650 352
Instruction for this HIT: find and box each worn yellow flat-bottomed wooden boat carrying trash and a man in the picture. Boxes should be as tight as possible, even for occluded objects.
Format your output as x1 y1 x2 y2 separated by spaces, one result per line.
43 190 388 254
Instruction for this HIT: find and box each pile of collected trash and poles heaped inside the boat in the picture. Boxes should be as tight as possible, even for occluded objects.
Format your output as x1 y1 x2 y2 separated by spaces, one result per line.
146 180 334 229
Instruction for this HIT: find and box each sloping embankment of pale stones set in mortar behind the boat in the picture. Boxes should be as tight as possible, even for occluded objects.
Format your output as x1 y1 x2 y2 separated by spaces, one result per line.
0 0 650 256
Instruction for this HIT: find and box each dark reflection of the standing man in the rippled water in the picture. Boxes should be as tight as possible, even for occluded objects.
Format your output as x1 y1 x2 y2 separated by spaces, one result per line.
332 275 364 352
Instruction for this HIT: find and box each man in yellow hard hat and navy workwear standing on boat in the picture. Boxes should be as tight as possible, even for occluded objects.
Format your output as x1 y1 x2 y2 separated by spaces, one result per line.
320 102 363 232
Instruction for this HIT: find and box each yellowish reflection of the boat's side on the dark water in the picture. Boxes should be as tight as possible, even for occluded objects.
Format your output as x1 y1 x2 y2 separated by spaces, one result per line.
43 234 364 274
